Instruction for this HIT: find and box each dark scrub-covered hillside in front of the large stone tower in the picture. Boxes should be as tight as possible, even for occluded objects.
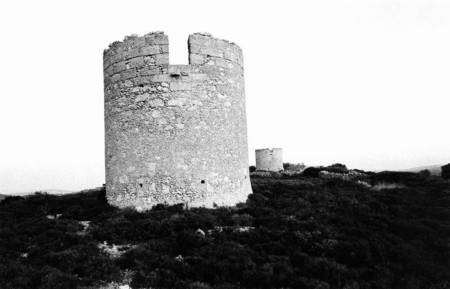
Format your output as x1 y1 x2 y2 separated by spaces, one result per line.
0 172 450 289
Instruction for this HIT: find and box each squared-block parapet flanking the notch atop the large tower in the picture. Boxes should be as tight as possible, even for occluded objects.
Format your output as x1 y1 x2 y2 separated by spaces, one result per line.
103 32 243 82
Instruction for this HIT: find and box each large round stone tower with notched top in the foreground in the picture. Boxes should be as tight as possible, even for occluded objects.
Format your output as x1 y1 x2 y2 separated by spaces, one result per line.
103 32 251 210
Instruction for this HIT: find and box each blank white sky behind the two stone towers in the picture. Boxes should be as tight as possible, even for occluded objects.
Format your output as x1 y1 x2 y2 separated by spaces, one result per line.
0 0 450 194
